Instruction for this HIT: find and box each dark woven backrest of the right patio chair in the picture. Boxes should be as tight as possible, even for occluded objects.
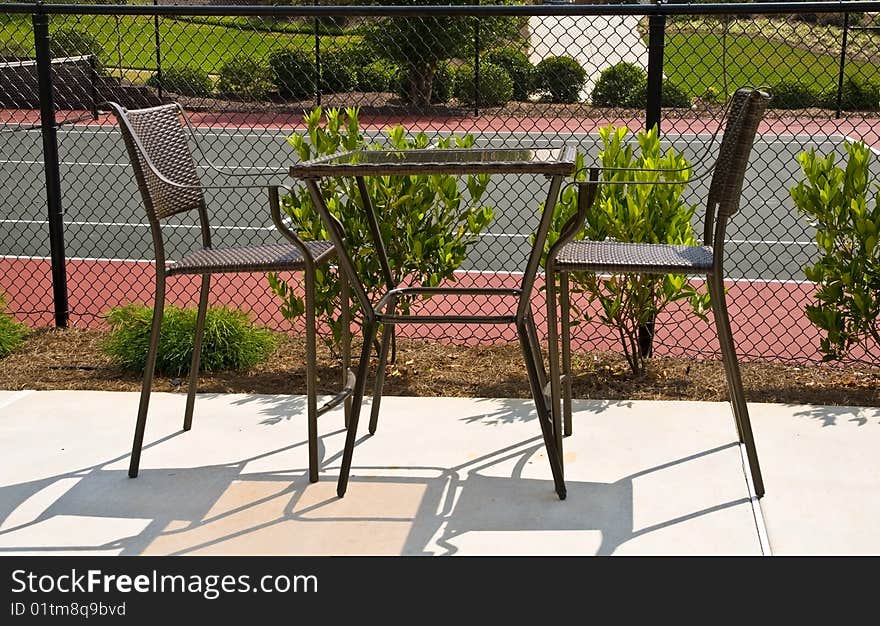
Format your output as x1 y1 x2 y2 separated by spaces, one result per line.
705 88 770 243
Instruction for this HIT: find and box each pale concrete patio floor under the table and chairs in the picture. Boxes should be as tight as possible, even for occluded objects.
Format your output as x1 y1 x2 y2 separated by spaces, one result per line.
0 391 880 555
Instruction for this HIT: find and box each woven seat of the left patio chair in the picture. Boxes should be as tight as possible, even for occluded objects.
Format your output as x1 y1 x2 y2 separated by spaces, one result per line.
166 241 333 275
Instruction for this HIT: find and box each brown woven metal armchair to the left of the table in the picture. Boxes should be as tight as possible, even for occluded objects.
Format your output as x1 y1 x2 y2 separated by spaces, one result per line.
107 102 354 482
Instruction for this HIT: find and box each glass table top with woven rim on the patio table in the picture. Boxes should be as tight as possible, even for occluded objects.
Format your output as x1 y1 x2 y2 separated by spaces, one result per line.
290 146 575 178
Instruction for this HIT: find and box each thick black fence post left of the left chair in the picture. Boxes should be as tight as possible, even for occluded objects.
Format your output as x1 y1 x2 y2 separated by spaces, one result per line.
32 6 69 328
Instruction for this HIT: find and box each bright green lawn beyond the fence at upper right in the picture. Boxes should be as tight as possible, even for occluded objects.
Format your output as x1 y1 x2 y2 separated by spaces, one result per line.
663 33 876 96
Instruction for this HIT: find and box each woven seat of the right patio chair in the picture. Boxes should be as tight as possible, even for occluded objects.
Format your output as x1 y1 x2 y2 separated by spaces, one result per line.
556 241 712 274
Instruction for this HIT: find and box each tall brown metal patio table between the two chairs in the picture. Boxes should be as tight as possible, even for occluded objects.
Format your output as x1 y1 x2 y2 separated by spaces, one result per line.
290 146 575 499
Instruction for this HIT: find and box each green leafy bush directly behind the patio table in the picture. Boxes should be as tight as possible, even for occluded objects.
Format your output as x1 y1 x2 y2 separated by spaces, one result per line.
269 107 492 352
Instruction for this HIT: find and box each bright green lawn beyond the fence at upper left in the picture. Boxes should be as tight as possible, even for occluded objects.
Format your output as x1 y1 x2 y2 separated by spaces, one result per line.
0 15 360 73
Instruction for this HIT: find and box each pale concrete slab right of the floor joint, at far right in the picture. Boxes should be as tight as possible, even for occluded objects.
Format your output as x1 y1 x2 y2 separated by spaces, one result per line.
752 404 880 555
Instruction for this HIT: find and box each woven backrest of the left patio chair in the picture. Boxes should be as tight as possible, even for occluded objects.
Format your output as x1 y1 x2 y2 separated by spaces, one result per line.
107 102 205 226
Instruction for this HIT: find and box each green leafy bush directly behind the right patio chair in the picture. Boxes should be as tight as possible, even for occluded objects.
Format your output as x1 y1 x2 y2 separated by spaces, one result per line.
544 126 710 374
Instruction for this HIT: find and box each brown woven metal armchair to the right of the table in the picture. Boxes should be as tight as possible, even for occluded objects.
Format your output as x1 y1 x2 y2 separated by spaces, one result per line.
546 88 769 497
